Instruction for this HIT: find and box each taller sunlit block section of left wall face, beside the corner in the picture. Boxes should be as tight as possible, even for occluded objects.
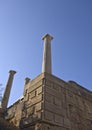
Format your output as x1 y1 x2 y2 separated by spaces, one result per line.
20 74 44 129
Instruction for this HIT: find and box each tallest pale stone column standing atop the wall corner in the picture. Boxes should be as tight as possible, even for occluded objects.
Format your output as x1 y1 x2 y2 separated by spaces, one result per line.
42 34 53 74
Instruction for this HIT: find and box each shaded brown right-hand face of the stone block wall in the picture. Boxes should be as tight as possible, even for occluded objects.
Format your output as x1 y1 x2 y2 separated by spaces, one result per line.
43 74 92 130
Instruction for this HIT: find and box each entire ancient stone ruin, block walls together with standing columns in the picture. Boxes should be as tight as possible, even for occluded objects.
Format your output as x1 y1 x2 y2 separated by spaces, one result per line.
0 34 92 130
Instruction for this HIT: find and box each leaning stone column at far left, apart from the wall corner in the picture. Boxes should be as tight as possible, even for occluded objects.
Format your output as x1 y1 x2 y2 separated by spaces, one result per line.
1 70 16 110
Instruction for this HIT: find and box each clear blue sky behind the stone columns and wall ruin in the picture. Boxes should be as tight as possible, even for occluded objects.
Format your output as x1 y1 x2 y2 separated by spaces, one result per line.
0 0 92 105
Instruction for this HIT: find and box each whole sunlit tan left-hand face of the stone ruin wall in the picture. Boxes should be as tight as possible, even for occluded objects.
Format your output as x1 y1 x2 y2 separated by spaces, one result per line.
6 74 44 129
